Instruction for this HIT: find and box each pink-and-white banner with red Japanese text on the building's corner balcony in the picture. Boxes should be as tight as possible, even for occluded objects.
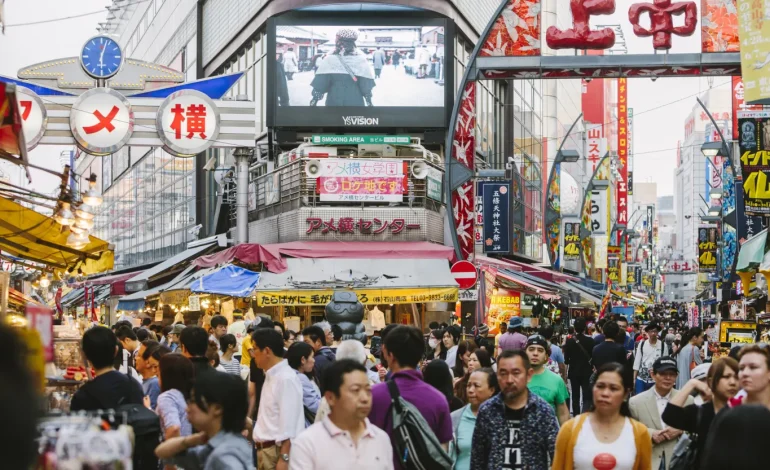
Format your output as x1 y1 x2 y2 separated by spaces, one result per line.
316 177 407 202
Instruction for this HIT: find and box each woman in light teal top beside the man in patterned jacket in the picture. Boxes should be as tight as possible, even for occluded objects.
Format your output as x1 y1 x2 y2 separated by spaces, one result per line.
452 367 500 470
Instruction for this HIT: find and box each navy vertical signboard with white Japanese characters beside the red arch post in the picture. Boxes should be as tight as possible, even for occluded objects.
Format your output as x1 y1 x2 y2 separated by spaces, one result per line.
482 182 511 254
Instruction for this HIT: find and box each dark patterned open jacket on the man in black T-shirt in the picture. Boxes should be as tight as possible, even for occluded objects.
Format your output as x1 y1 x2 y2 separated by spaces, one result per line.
471 391 559 470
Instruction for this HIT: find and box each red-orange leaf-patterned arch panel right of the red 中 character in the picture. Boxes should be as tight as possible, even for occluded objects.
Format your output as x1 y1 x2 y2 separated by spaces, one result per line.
700 0 741 53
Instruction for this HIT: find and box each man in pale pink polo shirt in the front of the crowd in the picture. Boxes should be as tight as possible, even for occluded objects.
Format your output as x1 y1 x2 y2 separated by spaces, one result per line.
289 359 393 470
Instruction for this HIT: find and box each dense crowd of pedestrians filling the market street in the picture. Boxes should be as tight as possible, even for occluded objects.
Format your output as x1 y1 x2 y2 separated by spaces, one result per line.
7 304 770 470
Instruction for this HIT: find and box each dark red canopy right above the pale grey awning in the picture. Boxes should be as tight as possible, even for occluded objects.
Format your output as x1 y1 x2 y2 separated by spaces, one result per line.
195 242 454 273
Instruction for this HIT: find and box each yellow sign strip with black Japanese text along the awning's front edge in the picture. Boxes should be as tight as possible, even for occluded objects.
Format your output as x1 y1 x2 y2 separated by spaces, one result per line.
256 287 458 307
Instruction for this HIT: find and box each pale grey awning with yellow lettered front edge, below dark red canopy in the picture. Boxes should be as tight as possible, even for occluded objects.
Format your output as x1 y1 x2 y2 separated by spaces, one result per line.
256 258 458 307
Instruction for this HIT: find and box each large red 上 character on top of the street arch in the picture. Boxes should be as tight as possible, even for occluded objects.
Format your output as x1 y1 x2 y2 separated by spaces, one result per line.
545 0 615 49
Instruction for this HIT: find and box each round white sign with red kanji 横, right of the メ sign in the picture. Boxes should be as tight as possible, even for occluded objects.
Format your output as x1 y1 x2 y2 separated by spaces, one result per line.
156 90 219 157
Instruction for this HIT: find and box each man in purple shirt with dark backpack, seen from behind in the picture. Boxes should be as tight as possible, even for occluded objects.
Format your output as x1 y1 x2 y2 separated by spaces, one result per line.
369 325 452 469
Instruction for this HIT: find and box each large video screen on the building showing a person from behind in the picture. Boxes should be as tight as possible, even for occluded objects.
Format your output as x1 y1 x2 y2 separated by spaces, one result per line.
268 18 453 128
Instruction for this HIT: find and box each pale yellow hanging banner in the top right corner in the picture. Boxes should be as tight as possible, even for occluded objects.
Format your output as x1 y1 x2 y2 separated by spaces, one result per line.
738 0 770 104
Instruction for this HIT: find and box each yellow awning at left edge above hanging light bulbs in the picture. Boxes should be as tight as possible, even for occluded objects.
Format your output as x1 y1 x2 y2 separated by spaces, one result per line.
0 198 114 275
